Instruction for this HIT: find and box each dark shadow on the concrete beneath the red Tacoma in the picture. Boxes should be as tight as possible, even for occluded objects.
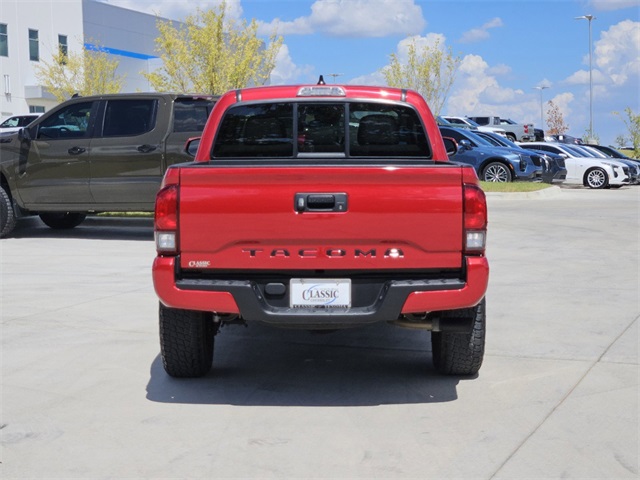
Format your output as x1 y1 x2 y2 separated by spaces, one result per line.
147 324 473 407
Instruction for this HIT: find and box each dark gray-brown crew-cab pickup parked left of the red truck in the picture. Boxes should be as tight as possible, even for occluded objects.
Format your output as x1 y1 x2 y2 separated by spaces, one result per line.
0 93 217 237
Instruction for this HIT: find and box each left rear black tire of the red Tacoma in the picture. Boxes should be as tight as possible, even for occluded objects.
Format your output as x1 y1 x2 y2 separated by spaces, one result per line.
159 304 216 378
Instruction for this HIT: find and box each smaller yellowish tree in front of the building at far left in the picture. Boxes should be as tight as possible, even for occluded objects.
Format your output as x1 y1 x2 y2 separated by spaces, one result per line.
34 42 125 102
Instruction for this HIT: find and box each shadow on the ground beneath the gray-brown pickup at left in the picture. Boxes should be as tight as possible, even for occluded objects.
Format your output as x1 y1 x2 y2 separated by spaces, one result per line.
8 215 153 241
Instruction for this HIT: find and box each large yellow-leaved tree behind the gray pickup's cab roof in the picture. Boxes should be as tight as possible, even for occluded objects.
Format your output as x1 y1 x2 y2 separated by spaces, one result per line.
142 2 282 94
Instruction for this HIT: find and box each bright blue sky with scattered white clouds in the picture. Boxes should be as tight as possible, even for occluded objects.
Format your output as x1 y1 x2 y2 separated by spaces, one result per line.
96 0 640 144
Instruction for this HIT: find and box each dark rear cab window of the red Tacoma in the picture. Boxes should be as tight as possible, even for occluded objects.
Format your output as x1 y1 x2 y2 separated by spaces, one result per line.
211 101 431 161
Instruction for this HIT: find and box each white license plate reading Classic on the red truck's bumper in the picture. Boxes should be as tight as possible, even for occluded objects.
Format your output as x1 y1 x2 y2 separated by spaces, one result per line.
289 278 351 308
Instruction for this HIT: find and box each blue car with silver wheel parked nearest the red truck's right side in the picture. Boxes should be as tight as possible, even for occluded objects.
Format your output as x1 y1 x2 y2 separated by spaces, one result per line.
440 126 542 182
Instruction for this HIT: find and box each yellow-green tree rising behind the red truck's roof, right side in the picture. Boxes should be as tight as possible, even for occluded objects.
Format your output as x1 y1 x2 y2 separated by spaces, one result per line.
382 38 462 115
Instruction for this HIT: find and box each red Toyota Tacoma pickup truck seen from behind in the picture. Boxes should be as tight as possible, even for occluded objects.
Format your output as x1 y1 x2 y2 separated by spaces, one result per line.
153 85 489 377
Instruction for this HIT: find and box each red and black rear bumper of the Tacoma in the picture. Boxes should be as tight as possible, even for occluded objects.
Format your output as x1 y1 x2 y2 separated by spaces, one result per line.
153 257 489 328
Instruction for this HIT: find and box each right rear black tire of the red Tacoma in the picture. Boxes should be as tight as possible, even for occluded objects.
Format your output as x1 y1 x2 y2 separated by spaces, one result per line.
431 298 486 375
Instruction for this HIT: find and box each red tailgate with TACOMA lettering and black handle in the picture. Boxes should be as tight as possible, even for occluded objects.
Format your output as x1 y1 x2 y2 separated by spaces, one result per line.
179 164 463 270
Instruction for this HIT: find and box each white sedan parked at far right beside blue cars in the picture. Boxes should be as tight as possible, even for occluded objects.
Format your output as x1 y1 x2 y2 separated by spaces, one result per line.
520 142 630 188
